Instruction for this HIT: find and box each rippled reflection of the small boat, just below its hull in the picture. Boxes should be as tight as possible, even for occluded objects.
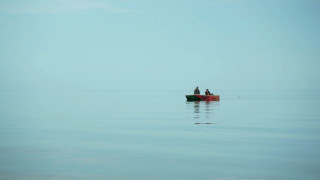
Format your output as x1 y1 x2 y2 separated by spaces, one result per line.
186 101 219 120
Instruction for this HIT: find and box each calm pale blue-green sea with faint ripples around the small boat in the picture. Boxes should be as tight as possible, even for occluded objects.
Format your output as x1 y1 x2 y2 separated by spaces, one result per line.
0 90 320 180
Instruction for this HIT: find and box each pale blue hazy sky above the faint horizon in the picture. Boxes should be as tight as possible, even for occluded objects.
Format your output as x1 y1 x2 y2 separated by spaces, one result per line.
0 0 320 91
